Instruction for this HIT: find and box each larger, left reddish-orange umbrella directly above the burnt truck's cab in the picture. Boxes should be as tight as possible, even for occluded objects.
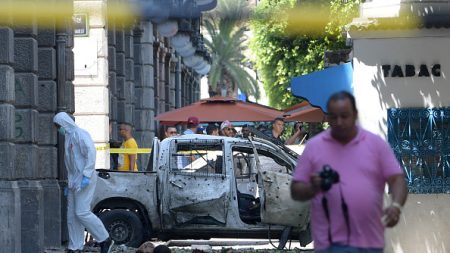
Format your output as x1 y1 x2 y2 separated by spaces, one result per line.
156 96 283 125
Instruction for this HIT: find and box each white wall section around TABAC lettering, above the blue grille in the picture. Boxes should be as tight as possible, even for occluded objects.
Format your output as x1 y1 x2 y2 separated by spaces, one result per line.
352 30 450 137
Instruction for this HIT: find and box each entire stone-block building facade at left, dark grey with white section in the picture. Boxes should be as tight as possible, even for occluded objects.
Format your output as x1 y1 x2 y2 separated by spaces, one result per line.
0 0 210 253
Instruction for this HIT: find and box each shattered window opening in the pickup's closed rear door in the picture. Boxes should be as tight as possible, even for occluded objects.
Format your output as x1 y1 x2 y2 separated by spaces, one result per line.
171 141 225 174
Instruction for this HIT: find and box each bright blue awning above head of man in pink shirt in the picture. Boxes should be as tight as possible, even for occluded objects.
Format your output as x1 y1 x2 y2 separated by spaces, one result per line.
291 62 353 112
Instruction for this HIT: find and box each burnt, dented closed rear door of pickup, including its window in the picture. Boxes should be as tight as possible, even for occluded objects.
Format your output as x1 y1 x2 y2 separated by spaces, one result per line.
163 139 231 227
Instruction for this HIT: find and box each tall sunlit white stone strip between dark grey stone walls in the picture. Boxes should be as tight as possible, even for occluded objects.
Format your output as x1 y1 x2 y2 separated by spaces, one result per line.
73 0 109 169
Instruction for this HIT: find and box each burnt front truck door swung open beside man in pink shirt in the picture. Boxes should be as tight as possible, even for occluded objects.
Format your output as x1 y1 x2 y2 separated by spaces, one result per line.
256 146 309 228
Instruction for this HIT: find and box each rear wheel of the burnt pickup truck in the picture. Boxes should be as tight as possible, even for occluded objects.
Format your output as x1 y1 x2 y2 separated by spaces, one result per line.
99 209 144 248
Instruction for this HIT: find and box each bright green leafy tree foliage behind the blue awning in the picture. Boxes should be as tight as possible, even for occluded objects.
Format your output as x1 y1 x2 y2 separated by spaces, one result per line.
250 0 360 108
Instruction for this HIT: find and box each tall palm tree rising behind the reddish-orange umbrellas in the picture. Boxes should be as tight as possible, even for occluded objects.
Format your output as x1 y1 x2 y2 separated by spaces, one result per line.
203 0 260 99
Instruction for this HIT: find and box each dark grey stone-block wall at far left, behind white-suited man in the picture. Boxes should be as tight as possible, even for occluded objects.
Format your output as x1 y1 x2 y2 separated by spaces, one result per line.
0 1 74 252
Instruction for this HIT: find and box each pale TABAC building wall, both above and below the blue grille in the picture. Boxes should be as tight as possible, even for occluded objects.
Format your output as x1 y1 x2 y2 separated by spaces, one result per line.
351 29 450 253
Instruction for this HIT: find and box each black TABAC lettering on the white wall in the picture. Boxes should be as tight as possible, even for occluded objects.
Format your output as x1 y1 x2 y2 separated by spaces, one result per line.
381 64 441 77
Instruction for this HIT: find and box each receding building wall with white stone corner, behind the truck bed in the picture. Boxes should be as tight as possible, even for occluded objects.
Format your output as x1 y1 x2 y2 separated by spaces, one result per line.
74 3 199 170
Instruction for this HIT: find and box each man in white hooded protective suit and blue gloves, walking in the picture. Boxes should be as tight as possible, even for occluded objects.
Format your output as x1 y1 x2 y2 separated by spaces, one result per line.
53 112 114 253
